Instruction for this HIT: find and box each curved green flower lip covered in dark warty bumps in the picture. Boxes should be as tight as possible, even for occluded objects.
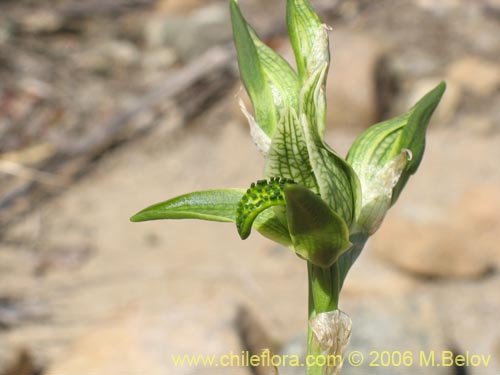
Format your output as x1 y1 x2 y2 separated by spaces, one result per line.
236 177 294 240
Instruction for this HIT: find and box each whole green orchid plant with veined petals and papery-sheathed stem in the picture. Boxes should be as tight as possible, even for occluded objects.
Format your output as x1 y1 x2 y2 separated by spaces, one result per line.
131 0 445 375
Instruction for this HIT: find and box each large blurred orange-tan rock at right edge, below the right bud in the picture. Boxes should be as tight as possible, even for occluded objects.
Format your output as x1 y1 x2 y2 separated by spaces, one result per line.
374 187 500 277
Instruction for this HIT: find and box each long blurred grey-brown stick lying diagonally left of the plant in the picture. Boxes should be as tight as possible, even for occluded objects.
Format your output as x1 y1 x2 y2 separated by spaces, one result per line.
0 46 234 234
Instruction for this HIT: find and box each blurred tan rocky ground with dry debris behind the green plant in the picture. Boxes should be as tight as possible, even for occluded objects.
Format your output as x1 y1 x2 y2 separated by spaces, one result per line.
0 0 500 375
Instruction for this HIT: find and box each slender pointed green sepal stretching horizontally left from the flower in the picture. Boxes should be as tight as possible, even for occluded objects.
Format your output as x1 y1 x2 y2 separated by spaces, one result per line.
130 189 245 222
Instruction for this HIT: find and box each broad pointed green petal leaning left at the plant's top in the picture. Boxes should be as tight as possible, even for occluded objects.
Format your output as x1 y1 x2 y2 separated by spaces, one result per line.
231 0 299 138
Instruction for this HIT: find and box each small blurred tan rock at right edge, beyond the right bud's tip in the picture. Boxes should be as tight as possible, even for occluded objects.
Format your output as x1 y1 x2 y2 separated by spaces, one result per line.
447 56 500 96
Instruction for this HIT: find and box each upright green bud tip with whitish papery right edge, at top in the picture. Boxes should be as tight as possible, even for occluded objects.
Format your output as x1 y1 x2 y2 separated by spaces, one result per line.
286 0 329 83
